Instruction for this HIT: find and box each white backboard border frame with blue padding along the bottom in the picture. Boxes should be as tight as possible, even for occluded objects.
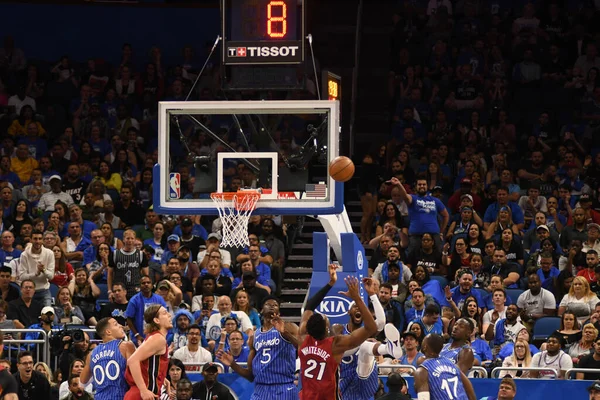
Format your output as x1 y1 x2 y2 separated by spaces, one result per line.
153 100 344 215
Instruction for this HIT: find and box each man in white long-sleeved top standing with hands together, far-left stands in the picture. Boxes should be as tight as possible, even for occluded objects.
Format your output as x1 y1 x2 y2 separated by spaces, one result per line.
17 231 55 306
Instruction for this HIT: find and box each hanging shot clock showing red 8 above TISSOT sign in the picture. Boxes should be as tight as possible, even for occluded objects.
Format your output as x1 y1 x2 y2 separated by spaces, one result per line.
221 0 305 65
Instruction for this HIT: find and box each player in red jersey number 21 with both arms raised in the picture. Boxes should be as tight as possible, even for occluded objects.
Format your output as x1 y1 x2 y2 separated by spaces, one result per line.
298 265 377 400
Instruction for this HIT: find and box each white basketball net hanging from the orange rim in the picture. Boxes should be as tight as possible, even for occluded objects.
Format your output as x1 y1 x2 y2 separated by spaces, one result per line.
210 190 260 247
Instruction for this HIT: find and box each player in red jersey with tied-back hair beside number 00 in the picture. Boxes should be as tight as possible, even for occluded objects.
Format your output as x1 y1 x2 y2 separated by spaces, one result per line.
124 304 173 400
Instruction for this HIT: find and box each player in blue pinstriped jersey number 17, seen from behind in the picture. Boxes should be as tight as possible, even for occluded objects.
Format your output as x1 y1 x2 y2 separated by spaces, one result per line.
415 333 477 400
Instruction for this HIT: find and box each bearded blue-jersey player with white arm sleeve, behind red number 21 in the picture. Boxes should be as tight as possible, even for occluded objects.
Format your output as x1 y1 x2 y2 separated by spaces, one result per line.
333 278 402 400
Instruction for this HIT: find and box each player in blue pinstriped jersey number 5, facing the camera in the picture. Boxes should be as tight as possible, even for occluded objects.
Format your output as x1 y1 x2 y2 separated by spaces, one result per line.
217 296 298 400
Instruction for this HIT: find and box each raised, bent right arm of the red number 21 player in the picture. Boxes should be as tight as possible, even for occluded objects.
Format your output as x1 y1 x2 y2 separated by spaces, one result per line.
333 276 377 355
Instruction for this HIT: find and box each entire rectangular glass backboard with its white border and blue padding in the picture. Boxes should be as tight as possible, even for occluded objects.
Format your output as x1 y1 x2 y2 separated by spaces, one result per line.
153 100 343 215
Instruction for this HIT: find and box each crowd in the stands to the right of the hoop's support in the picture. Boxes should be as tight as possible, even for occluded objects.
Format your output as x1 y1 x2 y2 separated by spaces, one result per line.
358 0 600 388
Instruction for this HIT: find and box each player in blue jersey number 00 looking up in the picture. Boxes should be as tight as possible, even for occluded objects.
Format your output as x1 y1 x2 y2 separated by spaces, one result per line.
81 318 135 400
